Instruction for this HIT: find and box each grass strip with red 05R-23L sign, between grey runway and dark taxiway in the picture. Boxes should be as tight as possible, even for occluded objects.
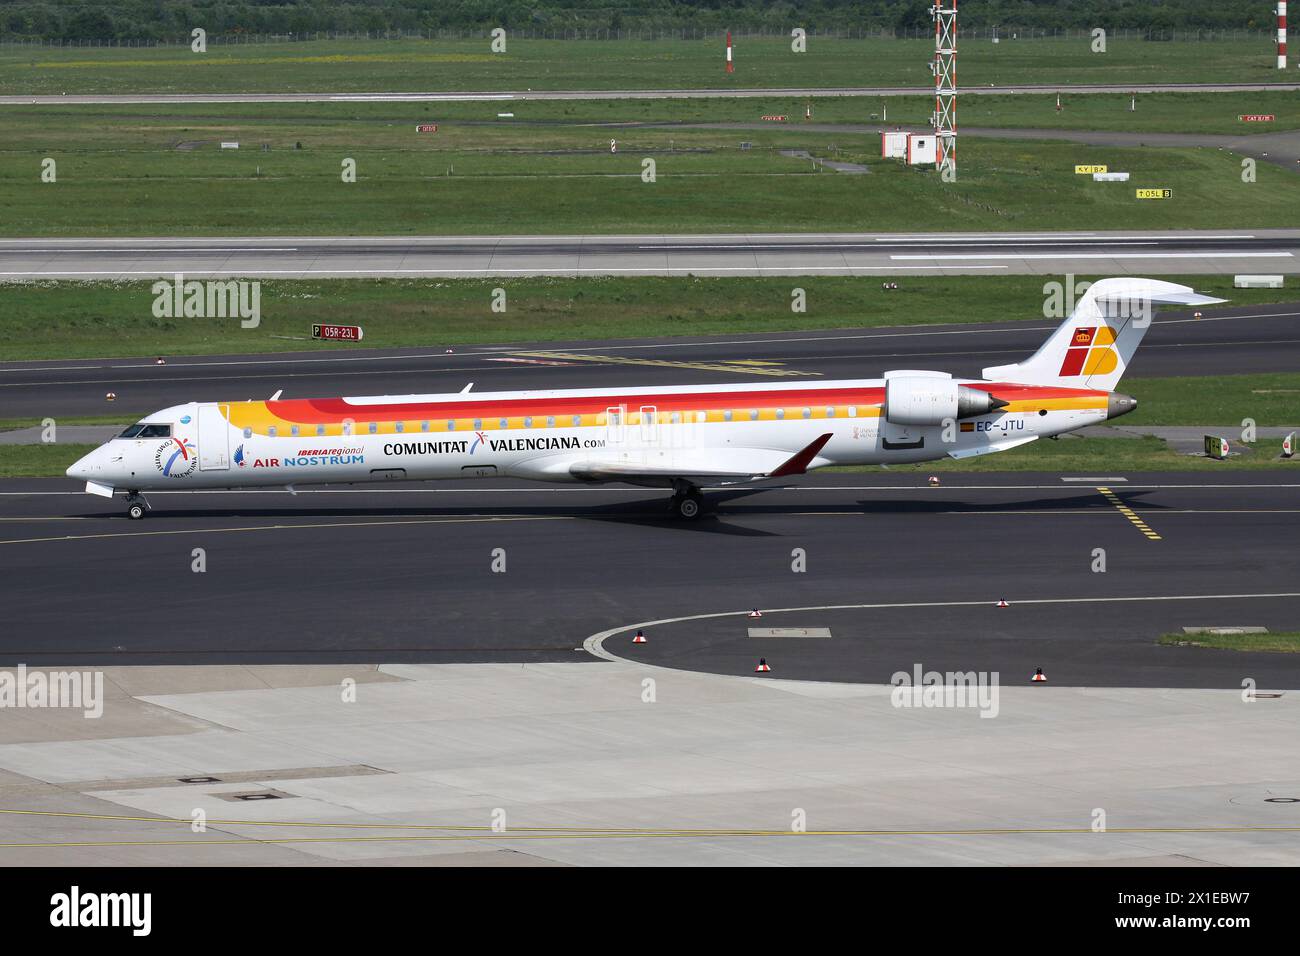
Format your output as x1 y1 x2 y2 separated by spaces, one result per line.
0 276 1295 366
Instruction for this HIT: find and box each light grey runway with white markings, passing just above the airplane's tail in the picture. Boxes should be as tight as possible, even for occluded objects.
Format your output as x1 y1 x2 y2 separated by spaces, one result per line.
0 229 1300 281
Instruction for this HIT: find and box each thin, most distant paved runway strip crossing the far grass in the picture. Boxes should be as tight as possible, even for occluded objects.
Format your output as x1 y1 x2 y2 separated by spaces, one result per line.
0 83 1300 107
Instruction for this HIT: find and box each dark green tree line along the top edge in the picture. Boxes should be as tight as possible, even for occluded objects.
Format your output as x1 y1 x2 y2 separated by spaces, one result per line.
0 0 1274 40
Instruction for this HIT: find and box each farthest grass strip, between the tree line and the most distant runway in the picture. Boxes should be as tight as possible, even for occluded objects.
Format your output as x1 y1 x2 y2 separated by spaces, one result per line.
0 33 1282 94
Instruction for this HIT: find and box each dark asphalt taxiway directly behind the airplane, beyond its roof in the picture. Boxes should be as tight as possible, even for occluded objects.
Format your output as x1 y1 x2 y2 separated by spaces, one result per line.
0 303 1300 421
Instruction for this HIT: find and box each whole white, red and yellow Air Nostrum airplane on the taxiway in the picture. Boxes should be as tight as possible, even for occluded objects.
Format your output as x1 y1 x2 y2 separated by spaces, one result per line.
68 278 1223 519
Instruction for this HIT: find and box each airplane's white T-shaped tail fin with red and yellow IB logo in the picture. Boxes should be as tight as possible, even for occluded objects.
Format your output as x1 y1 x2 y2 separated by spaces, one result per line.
984 278 1226 392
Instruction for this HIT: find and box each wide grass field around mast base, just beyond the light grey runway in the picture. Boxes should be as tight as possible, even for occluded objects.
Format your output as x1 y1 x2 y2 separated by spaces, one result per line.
0 120 1300 237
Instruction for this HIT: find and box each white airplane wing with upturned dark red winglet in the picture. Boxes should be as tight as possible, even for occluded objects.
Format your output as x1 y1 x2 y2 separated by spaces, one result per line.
568 432 831 485
